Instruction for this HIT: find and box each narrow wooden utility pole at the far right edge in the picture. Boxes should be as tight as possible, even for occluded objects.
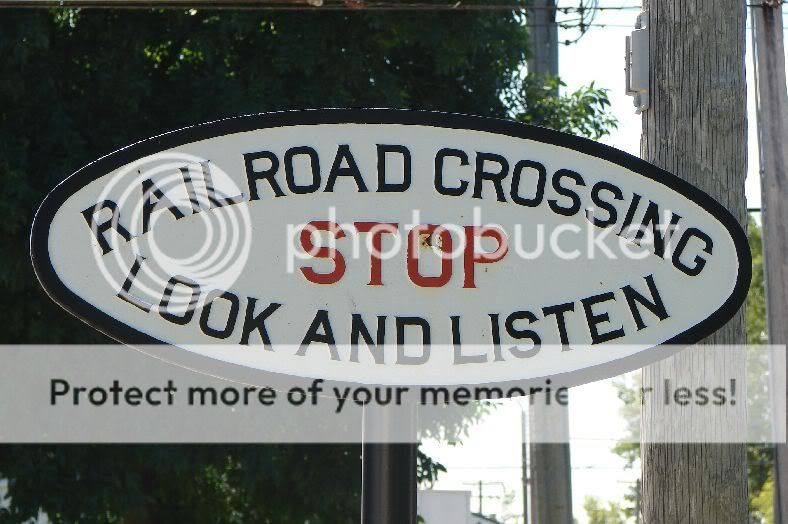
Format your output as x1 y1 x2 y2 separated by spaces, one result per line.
751 0 788 524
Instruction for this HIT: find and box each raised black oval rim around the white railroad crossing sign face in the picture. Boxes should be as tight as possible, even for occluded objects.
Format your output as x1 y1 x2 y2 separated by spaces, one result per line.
30 108 752 388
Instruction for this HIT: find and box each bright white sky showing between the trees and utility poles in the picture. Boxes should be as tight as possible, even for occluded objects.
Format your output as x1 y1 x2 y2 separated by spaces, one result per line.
422 0 788 524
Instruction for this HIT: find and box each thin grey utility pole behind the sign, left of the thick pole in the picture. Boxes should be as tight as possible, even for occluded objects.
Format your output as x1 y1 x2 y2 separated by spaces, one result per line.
523 4 573 524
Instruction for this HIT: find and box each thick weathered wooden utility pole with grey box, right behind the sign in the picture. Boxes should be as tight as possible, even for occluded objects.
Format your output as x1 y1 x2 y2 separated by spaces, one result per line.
641 0 748 524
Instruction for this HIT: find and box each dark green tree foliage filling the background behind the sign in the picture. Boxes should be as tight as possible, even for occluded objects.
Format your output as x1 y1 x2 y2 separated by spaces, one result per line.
0 9 612 523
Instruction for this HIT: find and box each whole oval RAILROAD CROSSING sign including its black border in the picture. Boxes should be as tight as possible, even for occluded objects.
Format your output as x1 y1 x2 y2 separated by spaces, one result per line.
31 110 751 385
